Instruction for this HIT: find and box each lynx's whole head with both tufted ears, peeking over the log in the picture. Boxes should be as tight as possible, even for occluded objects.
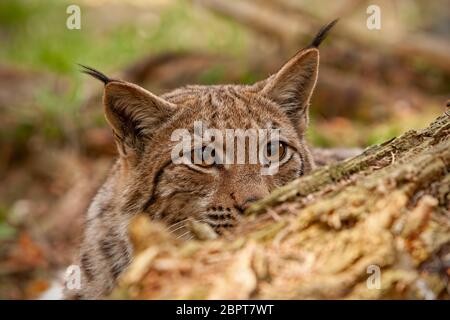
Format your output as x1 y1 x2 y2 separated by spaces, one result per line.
81 21 336 238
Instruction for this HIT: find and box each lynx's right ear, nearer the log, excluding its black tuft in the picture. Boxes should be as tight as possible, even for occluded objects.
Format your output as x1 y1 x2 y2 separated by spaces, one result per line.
262 48 319 130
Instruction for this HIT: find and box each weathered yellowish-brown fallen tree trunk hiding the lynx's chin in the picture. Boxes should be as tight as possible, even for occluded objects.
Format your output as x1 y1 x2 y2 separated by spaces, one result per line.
112 113 450 299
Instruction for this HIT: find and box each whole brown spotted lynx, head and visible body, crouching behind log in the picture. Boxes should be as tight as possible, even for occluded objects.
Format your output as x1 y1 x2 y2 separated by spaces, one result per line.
66 21 336 299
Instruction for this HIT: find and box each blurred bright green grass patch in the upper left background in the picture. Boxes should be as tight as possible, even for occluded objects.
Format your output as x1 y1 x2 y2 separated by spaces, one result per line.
0 0 246 76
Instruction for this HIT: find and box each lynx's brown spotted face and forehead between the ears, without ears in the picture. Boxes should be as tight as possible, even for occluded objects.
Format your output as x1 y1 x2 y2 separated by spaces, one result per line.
146 86 312 236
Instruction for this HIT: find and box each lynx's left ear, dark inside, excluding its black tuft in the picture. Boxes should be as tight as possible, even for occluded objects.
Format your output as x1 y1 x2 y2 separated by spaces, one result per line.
103 81 176 155
